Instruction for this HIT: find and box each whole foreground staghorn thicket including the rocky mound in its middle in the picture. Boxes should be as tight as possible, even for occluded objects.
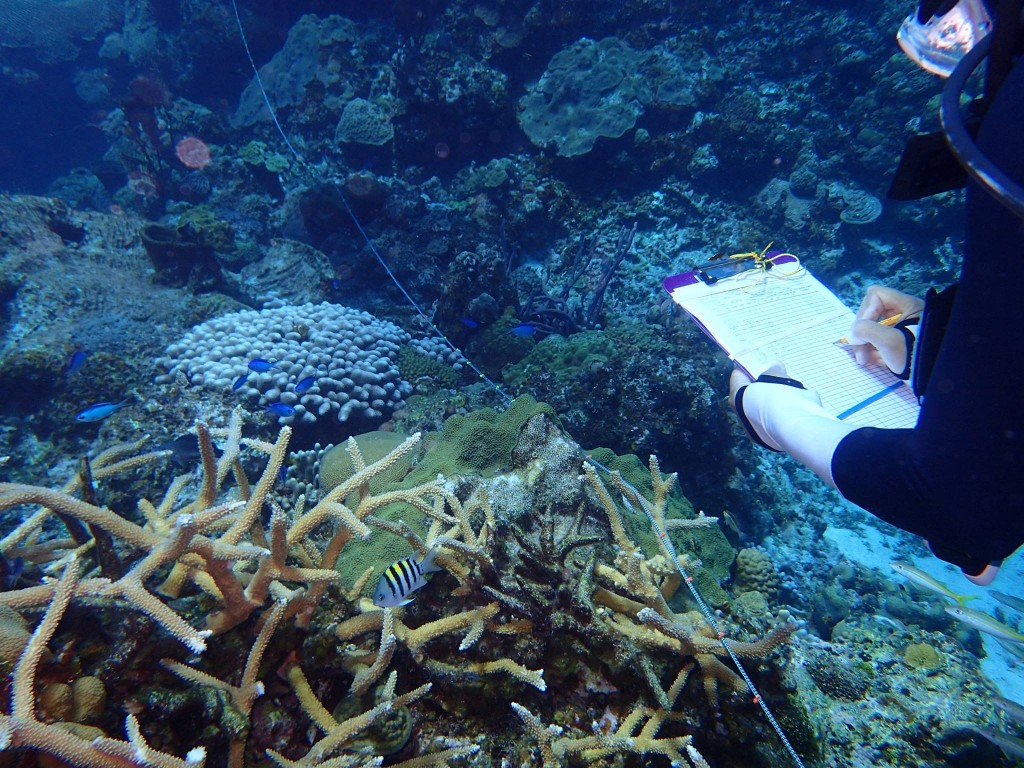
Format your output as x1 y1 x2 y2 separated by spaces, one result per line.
0 409 806 768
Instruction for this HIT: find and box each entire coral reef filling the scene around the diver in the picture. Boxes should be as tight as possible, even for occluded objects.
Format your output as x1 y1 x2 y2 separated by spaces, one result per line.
0 0 1020 768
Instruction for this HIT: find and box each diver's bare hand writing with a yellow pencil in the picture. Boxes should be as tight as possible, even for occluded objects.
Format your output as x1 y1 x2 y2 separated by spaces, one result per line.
848 286 925 374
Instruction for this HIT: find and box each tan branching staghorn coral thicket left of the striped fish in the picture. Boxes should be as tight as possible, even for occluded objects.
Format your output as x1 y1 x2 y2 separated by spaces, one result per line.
0 413 486 768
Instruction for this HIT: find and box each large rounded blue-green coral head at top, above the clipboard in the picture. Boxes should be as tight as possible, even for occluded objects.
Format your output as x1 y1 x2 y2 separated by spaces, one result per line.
519 37 651 158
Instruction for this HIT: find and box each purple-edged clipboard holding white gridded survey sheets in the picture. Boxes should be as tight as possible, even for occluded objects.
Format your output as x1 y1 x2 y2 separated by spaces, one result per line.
663 252 921 429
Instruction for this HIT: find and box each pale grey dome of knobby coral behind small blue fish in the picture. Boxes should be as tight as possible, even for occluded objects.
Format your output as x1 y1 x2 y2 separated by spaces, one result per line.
157 302 412 423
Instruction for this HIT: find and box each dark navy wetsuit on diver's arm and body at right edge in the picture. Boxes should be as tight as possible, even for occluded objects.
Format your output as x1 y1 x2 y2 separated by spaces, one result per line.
831 55 1024 572
